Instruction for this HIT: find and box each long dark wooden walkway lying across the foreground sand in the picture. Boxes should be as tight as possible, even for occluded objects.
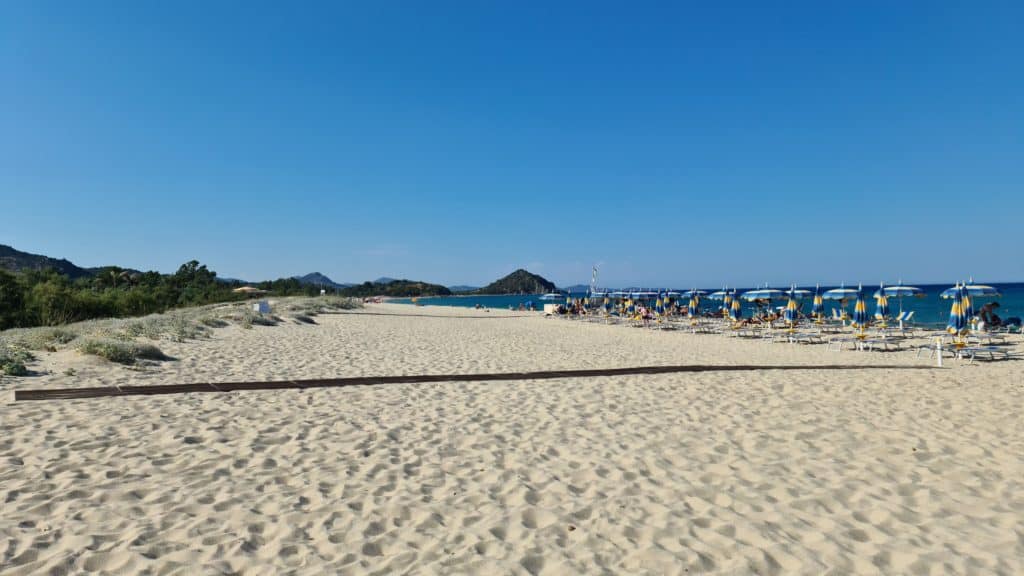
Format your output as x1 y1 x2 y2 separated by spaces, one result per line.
14 364 932 402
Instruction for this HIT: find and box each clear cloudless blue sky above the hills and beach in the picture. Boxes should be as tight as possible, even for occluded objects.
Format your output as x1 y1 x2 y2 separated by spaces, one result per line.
0 0 1024 286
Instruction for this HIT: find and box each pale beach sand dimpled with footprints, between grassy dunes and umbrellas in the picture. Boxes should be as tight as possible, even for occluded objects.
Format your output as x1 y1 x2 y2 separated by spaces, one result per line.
0 304 1024 574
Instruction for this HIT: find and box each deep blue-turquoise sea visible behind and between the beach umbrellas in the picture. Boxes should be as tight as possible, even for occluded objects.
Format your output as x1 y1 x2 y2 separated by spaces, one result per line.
391 282 1024 326
